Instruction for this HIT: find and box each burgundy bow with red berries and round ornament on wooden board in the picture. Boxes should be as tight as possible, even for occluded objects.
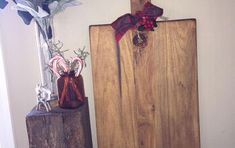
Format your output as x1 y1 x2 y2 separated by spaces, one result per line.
111 2 163 49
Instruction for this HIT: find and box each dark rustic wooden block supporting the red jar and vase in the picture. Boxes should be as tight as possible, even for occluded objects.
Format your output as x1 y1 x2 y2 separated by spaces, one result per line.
26 100 92 148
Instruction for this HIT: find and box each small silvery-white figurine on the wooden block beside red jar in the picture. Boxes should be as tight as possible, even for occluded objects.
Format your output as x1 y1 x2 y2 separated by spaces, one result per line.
35 84 51 112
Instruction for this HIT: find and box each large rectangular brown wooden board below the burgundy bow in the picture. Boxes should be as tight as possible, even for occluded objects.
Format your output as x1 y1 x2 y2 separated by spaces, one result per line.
90 19 200 148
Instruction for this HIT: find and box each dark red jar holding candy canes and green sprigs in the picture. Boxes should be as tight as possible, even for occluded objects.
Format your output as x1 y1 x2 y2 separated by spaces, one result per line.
49 44 89 109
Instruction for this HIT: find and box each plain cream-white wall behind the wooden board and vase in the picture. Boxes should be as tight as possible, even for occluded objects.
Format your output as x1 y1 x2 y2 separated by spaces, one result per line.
0 0 235 148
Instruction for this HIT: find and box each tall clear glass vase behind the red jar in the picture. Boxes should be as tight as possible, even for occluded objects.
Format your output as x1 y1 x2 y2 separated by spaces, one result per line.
36 17 58 101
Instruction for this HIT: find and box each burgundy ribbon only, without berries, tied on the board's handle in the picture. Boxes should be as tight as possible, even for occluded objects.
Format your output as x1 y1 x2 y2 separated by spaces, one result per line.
111 2 163 42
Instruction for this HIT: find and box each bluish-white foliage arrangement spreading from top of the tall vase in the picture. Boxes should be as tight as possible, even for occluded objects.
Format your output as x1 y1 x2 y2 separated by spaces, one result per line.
0 0 81 41
